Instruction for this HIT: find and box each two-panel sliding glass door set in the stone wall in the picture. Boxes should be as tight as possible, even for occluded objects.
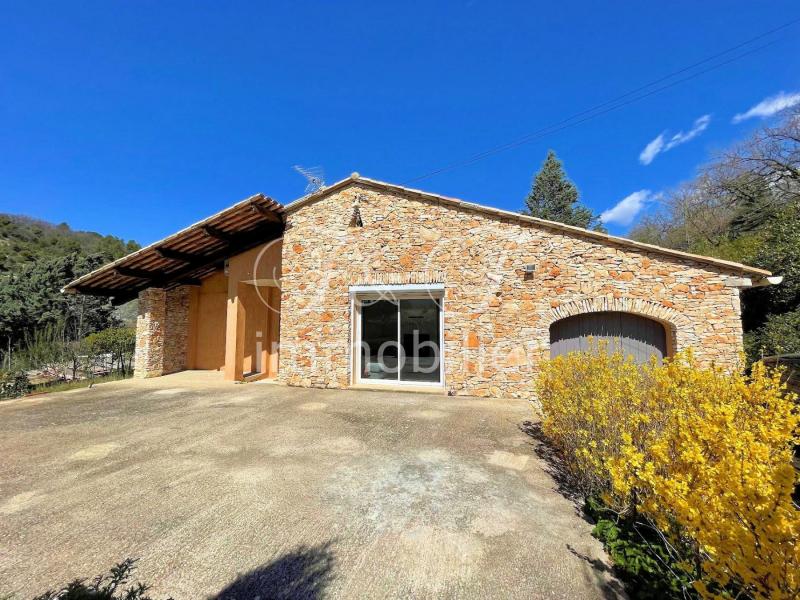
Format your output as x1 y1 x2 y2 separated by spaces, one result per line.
356 295 442 385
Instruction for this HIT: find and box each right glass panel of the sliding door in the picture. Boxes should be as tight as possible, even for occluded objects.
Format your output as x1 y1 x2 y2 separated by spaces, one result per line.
400 298 441 383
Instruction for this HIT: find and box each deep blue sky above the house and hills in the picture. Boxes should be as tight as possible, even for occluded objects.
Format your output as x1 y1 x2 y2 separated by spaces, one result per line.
0 0 800 243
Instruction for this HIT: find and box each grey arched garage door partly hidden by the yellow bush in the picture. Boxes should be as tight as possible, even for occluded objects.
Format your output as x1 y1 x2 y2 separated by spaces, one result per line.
550 312 667 363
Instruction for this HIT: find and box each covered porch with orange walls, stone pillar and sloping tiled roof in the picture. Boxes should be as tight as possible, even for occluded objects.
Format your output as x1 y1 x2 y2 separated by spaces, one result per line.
62 194 284 381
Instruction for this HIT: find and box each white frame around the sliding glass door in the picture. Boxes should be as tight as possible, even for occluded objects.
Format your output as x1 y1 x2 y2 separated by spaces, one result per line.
349 283 445 387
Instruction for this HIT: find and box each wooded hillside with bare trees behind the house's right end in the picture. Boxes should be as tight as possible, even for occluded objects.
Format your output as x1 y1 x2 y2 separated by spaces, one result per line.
630 108 800 360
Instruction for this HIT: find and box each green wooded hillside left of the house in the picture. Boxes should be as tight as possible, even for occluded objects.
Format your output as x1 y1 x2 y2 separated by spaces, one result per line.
0 214 139 368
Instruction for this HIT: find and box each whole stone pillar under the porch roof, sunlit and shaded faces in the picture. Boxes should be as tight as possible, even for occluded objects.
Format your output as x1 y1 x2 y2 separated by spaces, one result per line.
134 286 189 377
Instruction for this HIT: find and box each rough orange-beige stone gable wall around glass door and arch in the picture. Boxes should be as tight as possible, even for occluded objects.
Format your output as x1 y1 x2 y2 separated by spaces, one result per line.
279 182 742 397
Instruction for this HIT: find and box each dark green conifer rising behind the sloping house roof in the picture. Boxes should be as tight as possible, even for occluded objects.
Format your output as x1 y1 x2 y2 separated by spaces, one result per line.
522 150 603 231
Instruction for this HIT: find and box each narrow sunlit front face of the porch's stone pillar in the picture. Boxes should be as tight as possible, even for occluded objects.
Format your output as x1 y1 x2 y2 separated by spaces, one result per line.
133 288 167 378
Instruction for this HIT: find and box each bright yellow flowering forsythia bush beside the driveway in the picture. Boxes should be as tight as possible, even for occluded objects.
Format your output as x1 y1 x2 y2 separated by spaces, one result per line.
538 348 800 598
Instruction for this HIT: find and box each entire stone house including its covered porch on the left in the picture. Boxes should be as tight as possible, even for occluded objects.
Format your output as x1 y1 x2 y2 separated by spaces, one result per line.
64 174 779 397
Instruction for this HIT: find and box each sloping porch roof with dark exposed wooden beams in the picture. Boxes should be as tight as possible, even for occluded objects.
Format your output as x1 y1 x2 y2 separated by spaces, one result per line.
61 194 284 304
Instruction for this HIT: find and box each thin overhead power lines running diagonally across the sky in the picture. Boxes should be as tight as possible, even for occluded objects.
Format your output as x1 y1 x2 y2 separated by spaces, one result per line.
403 18 800 185
